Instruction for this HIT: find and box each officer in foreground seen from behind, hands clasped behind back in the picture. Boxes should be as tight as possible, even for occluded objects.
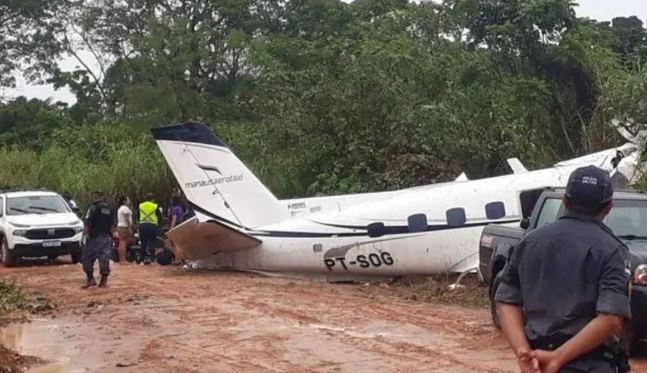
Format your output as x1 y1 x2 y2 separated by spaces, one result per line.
494 166 631 373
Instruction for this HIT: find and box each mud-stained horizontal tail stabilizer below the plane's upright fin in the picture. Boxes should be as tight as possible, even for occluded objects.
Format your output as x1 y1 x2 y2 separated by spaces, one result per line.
166 217 261 260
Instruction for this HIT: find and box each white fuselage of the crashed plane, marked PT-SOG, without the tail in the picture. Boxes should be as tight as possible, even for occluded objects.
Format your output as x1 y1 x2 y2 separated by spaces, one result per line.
191 166 577 277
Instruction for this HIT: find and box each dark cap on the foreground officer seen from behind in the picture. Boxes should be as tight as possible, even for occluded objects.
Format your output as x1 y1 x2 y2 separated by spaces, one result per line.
566 166 613 207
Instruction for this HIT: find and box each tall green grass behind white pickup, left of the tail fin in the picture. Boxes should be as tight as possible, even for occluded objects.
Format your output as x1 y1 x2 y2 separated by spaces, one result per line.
0 137 175 208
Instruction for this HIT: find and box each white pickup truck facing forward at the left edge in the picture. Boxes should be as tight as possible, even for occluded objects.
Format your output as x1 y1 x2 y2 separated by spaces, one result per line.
0 190 83 267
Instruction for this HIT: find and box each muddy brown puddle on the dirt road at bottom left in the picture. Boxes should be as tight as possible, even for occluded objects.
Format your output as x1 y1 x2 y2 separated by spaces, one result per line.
0 320 107 373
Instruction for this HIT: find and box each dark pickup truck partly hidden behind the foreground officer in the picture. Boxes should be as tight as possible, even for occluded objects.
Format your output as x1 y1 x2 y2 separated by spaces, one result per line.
479 188 647 339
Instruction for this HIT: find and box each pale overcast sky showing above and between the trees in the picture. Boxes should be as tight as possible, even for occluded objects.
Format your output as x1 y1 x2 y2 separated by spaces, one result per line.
0 0 647 104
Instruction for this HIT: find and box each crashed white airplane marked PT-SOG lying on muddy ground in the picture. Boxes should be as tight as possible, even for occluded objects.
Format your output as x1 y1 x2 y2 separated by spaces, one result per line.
152 122 642 282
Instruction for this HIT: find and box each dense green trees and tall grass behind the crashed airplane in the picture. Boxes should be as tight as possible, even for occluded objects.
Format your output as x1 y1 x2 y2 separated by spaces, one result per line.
0 0 647 206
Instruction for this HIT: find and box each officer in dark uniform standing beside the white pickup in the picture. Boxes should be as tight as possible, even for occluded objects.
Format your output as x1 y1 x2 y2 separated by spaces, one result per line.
81 191 115 289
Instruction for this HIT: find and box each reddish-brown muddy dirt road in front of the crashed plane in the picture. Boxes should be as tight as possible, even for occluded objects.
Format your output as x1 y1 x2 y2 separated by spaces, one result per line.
0 258 647 373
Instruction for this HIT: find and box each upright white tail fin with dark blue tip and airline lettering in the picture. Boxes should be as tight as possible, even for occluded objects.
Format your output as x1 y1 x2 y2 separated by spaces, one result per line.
151 122 280 228
